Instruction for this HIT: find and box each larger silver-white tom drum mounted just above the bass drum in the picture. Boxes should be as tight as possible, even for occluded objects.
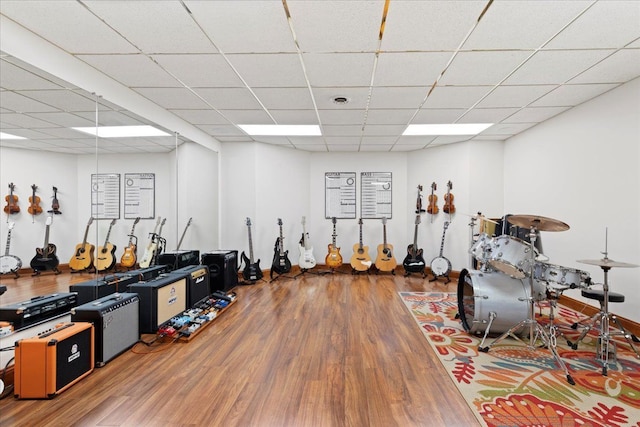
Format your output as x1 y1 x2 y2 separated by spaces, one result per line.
489 235 538 279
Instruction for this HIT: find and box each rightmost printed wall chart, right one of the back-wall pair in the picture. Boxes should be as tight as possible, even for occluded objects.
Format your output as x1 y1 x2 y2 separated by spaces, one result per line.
360 172 392 219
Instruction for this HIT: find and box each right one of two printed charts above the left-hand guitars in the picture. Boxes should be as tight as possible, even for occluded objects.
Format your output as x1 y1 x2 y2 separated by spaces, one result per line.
124 173 156 219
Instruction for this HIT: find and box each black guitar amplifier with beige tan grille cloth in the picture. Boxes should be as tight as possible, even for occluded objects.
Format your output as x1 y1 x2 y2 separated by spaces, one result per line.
129 273 188 334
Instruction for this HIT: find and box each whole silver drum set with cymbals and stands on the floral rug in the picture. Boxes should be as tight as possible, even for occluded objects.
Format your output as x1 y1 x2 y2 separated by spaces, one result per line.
458 215 640 385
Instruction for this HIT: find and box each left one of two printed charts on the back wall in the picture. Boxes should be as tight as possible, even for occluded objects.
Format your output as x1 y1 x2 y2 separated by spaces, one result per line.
324 172 356 218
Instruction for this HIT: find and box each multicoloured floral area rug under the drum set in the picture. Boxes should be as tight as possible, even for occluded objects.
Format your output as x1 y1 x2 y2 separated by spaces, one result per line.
400 292 640 427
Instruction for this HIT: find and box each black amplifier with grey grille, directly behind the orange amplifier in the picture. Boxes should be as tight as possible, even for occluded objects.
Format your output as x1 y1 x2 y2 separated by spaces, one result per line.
71 293 140 367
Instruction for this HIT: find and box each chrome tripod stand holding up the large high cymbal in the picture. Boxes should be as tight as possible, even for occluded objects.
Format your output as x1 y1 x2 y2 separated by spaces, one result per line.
478 225 576 385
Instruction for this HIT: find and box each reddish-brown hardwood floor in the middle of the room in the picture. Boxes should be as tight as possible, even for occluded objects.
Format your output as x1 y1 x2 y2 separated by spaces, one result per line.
0 265 479 427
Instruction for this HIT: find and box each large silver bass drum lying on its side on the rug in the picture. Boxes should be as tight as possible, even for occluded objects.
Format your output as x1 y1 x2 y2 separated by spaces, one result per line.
458 269 547 334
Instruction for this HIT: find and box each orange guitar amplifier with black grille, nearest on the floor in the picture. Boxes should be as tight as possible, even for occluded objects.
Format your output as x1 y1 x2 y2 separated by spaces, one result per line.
14 322 94 399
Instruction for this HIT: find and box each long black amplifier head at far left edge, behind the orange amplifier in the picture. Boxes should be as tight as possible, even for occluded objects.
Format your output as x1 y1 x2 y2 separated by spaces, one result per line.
0 292 78 329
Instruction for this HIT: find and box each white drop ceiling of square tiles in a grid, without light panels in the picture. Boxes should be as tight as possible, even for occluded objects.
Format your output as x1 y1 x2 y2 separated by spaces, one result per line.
0 0 640 153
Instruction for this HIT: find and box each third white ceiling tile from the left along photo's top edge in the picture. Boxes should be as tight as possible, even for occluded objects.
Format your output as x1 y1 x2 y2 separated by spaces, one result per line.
185 1 296 53
